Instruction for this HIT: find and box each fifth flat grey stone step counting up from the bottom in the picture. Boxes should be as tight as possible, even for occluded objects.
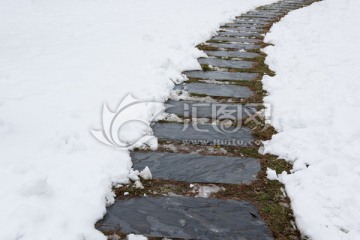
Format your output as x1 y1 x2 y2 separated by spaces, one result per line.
175 82 254 98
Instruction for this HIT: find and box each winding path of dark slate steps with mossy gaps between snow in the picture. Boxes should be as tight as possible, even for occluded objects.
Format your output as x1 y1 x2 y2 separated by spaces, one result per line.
96 0 314 240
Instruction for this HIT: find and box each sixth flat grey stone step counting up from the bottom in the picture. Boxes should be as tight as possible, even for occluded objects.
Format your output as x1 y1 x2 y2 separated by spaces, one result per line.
184 70 259 81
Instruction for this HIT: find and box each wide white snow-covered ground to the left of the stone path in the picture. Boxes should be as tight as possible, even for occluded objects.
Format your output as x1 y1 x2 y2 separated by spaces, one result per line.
0 0 273 240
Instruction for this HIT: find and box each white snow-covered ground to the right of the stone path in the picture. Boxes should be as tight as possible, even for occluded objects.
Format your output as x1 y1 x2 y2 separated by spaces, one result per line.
263 0 360 240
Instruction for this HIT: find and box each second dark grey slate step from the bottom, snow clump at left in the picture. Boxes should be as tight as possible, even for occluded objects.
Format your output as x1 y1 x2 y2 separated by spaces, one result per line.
131 152 260 184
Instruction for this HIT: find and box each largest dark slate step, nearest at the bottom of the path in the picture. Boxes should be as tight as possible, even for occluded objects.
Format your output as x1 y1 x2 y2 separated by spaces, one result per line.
97 196 273 240
